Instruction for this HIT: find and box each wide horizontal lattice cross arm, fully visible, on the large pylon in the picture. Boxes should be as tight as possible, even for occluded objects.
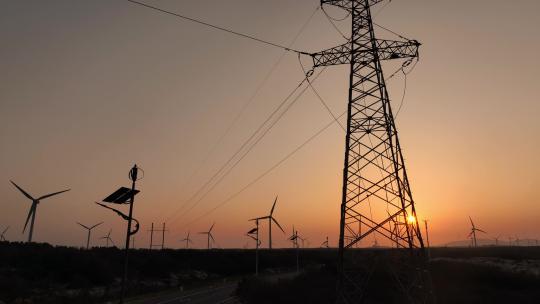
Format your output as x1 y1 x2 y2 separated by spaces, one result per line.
310 39 420 67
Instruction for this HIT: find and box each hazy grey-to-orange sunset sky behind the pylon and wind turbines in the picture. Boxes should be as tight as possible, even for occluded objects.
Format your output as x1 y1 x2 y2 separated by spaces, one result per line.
0 0 540 247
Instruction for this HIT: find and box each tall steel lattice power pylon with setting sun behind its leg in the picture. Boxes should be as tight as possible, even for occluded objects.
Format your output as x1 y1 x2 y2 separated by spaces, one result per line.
311 0 431 303
